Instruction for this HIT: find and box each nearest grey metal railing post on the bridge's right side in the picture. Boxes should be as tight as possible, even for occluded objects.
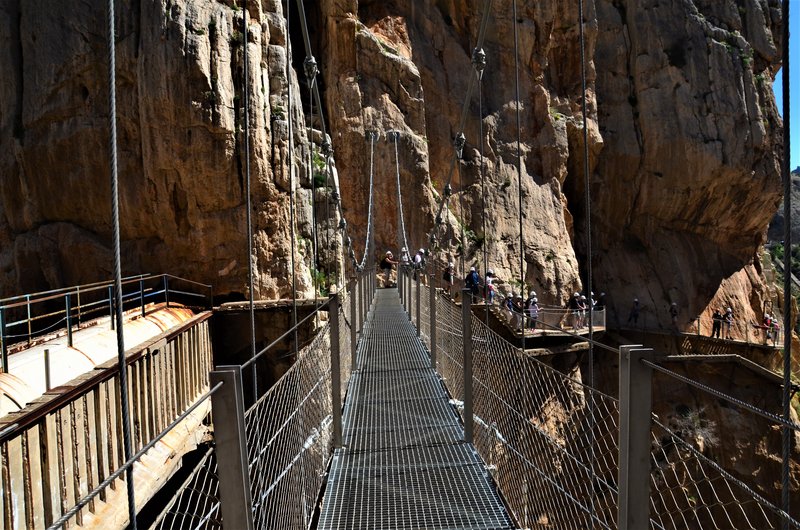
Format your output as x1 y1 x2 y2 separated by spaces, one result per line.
617 345 654 530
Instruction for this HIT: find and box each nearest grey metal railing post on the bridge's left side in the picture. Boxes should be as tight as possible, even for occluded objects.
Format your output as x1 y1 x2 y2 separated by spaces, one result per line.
209 366 253 530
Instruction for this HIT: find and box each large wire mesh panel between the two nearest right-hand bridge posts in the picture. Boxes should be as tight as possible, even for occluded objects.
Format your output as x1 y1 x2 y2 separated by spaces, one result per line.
472 315 619 529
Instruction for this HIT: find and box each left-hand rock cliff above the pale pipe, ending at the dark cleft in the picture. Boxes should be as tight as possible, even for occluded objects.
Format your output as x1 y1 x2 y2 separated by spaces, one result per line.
0 0 334 298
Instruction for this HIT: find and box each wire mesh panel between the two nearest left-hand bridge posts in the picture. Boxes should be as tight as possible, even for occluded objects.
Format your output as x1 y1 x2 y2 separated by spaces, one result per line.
245 325 332 528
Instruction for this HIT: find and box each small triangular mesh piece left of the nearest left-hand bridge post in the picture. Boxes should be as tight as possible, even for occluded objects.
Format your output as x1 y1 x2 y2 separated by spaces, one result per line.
150 447 222 530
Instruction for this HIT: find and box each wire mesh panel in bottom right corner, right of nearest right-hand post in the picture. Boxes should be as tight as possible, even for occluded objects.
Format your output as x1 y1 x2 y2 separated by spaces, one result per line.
650 421 800 530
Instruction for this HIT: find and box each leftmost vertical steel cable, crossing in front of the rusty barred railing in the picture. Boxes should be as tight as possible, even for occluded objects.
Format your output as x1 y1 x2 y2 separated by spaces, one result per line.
108 0 138 530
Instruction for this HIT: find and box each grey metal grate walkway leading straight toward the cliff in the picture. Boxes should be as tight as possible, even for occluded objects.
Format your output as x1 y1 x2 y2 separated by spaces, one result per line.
318 289 513 530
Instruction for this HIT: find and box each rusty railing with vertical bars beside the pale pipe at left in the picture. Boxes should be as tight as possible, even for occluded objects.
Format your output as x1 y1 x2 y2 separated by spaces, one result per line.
0 312 212 529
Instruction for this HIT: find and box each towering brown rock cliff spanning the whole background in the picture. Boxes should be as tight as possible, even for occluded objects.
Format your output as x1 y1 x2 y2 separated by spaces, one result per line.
0 0 780 326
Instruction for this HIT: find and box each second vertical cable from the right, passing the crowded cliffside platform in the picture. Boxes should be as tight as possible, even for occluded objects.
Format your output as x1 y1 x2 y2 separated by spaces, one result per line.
578 0 595 528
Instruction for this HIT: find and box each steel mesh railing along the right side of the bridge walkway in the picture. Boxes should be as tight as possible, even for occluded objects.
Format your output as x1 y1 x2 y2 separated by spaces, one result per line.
421 291 800 530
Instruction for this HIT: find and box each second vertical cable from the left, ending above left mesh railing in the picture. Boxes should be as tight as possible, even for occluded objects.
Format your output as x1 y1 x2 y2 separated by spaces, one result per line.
242 0 258 396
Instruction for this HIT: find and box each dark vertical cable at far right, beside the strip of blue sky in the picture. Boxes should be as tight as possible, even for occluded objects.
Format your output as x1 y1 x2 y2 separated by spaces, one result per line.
781 0 792 530
